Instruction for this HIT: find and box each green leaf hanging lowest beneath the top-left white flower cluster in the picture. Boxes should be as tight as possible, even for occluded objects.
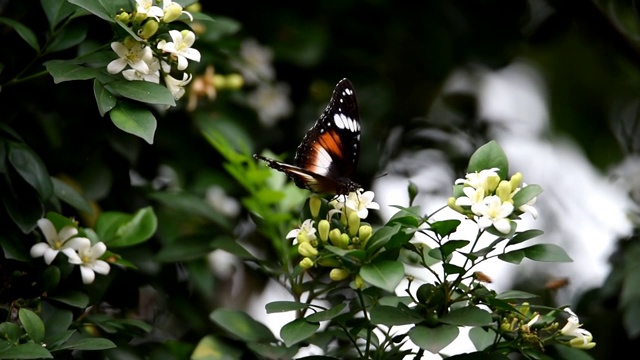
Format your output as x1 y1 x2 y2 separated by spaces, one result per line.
109 101 157 144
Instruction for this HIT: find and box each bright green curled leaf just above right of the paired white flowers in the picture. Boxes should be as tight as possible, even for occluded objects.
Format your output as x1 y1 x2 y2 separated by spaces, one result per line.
96 206 158 247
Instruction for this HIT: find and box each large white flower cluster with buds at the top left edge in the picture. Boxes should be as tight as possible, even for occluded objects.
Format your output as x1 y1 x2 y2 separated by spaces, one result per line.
107 0 200 100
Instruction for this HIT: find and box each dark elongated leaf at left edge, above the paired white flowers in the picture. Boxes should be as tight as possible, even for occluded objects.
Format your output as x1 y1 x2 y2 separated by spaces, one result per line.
7 141 53 200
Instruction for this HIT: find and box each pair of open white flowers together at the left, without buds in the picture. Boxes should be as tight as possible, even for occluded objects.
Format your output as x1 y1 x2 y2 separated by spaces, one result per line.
31 218 110 284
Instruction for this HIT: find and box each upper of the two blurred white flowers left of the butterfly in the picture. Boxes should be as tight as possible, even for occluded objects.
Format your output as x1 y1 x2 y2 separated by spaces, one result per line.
235 39 275 84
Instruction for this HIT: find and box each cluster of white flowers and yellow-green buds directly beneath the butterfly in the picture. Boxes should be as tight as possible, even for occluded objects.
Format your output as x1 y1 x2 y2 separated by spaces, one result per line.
286 189 380 285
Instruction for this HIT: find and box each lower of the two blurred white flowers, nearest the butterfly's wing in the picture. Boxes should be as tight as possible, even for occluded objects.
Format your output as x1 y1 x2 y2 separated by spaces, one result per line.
247 83 293 126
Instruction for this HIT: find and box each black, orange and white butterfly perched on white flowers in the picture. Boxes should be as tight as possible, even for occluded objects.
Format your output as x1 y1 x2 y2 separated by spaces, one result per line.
253 78 360 195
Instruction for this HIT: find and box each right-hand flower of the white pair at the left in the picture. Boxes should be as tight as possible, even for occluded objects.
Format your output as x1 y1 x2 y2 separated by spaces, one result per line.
62 237 111 284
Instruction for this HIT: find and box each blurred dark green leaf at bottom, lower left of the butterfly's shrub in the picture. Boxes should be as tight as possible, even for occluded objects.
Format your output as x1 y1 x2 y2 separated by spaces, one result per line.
209 308 276 341
